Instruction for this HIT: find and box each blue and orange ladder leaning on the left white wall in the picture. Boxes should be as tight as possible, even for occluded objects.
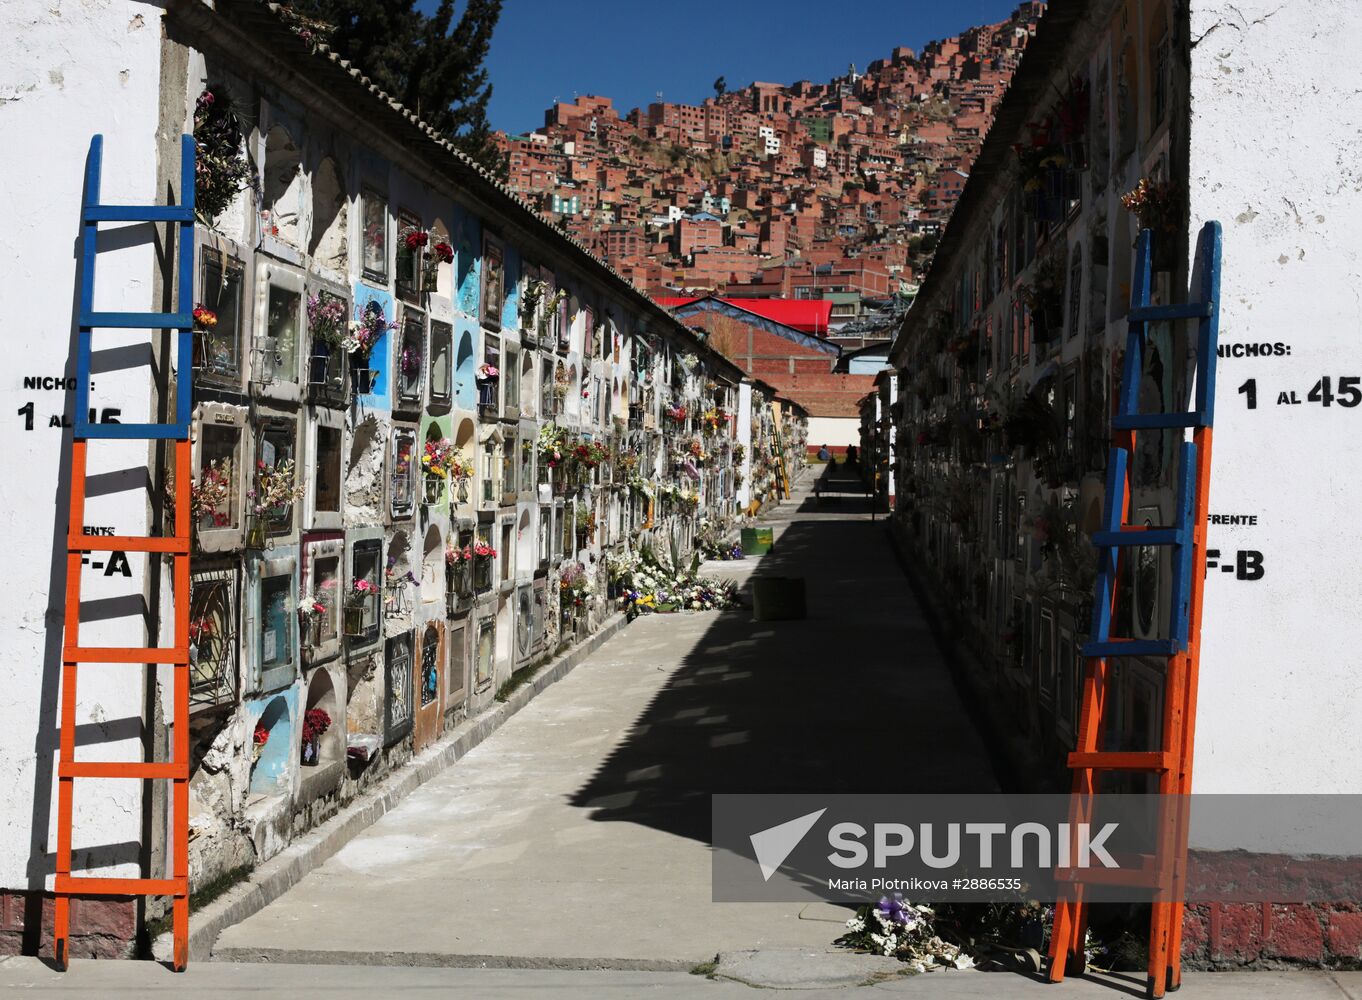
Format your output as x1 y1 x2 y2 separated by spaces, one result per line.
53 135 195 971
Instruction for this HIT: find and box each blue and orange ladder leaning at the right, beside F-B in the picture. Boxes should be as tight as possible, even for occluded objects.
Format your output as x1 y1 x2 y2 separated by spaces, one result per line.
1049 222 1220 997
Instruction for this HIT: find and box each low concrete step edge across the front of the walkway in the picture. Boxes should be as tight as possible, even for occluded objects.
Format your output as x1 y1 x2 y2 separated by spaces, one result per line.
212 948 703 973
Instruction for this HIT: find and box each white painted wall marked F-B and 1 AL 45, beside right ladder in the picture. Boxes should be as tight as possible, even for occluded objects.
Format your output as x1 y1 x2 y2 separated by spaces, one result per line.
1189 0 1362 793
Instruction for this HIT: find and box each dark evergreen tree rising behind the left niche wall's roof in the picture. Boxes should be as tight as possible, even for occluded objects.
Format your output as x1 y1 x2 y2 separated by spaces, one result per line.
290 0 505 177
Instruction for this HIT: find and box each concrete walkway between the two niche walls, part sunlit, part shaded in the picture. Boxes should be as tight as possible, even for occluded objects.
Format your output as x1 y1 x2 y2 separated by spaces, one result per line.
215 489 996 970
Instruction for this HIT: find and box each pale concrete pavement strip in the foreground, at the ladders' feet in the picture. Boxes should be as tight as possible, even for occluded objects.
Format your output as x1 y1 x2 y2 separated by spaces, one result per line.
0 958 1362 1000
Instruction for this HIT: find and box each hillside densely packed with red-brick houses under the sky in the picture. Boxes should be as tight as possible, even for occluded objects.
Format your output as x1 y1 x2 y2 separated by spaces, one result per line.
498 1 1045 317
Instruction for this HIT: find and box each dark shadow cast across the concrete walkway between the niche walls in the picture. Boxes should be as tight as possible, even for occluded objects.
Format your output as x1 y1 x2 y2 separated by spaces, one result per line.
572 490 997 842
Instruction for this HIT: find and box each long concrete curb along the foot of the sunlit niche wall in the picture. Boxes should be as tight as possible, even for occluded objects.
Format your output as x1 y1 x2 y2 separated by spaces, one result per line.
153 612 631 970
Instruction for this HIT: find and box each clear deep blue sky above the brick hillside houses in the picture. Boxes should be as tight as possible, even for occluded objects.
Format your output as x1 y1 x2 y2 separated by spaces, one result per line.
418 0 1016 132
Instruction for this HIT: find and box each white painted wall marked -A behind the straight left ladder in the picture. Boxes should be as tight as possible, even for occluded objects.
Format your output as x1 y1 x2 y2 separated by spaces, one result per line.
0 0 161 888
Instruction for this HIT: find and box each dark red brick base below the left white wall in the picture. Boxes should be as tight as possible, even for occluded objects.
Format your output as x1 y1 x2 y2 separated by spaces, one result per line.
0 891 138 958
